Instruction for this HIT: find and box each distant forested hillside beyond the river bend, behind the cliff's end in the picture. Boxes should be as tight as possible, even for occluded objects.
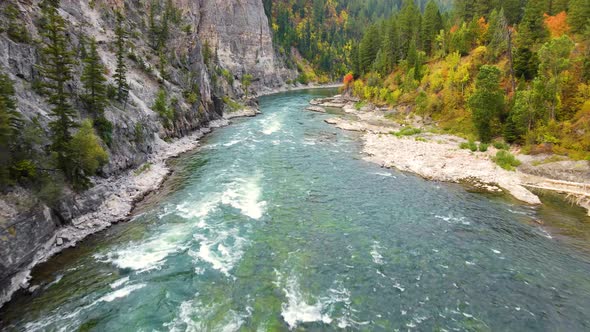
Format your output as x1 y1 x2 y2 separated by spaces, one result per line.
264 0 452 83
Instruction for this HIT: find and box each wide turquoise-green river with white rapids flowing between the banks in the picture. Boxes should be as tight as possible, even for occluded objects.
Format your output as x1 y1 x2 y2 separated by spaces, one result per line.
0 90 590 331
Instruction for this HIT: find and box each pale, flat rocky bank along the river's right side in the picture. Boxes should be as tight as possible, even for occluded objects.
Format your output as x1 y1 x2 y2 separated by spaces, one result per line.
310 95 590 214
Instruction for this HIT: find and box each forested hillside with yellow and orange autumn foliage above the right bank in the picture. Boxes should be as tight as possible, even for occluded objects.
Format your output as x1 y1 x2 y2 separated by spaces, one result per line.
347 0 590 159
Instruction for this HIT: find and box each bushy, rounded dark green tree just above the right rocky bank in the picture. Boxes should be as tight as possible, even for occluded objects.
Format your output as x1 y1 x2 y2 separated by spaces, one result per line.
468 65 504 142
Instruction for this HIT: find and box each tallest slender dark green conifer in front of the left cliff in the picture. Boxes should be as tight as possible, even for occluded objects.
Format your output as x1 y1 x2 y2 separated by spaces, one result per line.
38 2 77 181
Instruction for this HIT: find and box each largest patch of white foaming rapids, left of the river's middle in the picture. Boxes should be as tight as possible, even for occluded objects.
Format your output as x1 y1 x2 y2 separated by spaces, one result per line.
95 173 266 275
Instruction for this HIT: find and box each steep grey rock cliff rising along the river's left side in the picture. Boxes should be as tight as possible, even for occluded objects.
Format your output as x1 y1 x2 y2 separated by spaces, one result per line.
0 0 296 305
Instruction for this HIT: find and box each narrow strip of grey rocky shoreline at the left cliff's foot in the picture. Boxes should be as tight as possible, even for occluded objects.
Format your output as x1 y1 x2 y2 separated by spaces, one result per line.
0 107 261 307
